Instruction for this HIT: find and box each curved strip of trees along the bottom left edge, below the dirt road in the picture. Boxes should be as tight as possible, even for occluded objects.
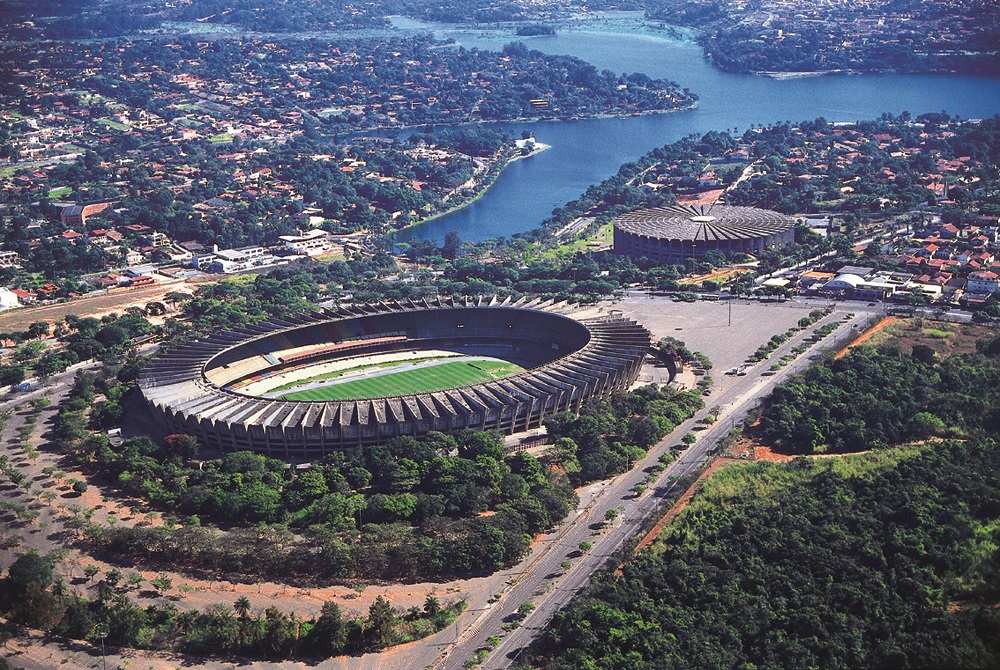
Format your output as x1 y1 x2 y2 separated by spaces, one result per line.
0 551 466 659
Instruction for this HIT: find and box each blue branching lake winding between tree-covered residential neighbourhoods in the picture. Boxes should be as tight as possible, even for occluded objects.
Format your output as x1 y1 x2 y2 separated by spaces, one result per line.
390 24 1000 242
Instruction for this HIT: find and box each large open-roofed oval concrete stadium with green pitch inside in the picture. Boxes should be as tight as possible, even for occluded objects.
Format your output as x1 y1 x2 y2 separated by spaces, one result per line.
139 299 650 459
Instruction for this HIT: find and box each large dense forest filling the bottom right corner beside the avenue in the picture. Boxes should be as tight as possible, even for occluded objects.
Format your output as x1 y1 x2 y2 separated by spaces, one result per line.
531 440 1000 670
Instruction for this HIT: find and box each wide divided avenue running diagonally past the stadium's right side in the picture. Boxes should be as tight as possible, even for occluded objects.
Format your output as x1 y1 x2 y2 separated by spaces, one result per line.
432 312 871 670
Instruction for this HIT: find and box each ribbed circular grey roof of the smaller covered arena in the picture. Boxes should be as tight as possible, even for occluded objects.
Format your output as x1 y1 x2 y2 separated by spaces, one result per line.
615 205 794 247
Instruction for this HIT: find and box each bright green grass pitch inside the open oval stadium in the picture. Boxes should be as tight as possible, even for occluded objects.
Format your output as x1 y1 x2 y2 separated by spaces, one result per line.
281 360 524 400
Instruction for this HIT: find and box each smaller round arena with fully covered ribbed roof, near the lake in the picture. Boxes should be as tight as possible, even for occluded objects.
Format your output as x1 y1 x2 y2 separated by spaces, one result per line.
614 205 795 264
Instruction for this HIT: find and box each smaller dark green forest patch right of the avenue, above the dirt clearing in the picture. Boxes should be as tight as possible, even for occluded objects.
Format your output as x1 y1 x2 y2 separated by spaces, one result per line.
759 334 1000 454
